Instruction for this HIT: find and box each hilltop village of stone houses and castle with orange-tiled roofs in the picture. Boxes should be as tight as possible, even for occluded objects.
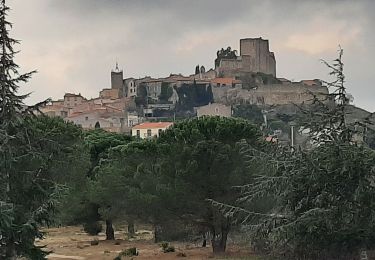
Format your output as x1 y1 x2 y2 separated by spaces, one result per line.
42 38 328 137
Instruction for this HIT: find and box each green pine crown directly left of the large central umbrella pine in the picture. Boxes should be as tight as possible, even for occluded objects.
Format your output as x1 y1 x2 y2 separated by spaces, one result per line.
90 140 158 220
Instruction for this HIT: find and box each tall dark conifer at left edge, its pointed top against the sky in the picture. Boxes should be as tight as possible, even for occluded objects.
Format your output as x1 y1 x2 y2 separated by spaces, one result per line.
0 0 59 259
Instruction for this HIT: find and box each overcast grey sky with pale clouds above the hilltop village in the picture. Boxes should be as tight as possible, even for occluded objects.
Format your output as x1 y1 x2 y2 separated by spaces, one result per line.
8 0 375 112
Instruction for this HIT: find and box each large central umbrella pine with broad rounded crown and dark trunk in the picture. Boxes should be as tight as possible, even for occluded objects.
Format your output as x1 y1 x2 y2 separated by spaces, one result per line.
158 117 261 252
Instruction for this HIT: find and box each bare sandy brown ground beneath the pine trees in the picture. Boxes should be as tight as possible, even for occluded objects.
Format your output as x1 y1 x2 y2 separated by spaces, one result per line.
37 227 256 260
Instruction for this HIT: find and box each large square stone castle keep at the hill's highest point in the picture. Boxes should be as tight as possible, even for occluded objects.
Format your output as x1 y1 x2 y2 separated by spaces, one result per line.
240 37 276 77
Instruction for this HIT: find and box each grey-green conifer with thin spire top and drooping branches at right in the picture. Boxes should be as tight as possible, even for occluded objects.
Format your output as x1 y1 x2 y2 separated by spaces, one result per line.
222 47 375 259
